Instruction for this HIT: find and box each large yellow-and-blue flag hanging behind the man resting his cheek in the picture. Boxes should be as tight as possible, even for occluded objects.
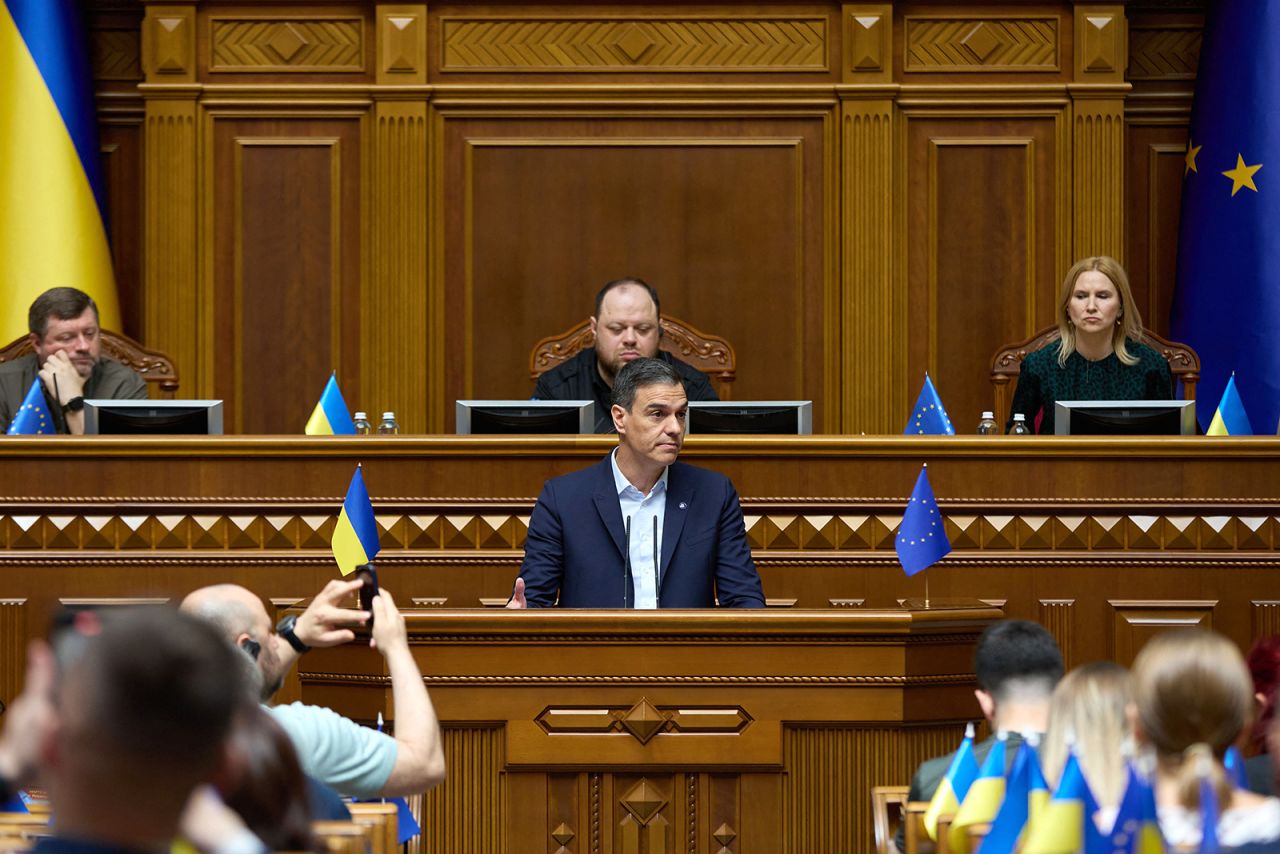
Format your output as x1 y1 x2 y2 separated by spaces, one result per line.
0 0 120 343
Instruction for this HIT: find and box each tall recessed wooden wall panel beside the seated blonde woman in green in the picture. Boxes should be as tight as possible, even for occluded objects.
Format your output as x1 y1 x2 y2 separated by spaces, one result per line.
899 110 1070 433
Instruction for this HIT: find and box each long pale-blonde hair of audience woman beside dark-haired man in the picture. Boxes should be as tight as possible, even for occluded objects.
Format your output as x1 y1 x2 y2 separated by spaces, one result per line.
1041 661 1133 807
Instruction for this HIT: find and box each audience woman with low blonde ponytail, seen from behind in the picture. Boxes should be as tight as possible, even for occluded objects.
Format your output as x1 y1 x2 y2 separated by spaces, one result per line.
1133 629 1280 848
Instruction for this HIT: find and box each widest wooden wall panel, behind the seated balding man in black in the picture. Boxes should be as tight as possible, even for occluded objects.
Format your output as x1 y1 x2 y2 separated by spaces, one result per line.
436 112 840 429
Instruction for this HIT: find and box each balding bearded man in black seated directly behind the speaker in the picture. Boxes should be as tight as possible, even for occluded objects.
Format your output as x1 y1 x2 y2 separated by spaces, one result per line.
534 277 719 433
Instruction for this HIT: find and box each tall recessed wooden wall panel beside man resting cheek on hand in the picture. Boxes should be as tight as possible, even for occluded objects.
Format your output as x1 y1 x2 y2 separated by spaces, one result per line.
206 108 366 434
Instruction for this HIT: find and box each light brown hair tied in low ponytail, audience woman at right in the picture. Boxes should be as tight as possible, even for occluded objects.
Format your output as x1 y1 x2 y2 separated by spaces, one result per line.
1133 629 1253 809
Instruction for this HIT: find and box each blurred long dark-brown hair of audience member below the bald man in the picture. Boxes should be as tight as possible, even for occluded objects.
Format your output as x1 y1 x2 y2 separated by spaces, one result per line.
221 704 315 851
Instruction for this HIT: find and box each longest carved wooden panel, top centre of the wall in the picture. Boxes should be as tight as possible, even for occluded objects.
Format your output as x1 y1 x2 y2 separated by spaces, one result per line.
440 15 829 72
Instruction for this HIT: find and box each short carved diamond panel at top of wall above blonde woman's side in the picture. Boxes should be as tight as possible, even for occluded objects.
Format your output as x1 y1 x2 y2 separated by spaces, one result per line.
904 15 1060 72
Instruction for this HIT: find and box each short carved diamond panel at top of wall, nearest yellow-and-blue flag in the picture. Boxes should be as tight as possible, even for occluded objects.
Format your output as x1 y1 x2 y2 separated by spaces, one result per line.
209 15 365 72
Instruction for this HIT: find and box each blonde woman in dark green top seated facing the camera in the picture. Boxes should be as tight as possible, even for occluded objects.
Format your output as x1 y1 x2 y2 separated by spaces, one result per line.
1009 255 1174 433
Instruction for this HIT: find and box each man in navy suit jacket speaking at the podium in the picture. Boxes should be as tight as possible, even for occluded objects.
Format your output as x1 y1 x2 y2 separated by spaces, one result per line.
507 359 764 608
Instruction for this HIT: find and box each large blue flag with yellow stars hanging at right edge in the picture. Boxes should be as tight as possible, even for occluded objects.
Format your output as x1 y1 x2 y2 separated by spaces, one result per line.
1171 0 1280 433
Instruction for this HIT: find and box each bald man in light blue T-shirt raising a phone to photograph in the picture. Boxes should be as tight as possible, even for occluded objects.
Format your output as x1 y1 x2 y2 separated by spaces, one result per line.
182 580 444 798
